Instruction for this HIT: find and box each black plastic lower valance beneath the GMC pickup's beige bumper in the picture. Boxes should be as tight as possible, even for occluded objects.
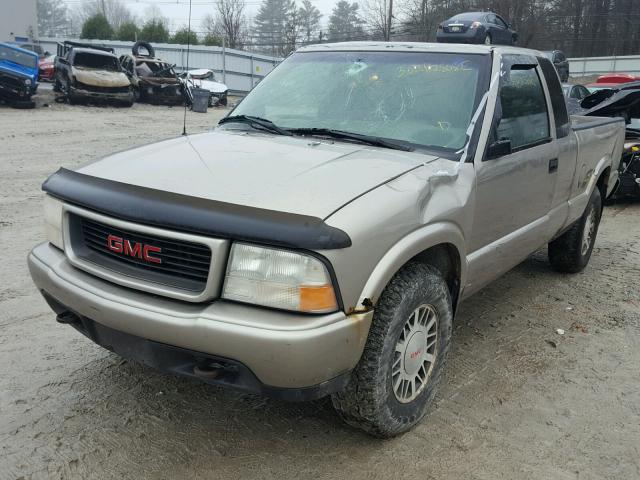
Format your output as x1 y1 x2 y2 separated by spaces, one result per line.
41 291 350 402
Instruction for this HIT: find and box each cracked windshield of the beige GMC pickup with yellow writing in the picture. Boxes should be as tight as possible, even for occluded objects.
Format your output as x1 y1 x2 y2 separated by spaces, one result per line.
233 52 488 151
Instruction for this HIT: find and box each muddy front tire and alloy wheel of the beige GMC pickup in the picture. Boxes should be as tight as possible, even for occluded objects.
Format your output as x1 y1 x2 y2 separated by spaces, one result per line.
331 263 453 437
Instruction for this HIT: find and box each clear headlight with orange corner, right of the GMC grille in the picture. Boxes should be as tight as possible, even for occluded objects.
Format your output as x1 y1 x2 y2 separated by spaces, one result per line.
222 243 338 313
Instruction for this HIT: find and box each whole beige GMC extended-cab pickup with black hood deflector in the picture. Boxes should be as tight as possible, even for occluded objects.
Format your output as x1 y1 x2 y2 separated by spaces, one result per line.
28 43 624 437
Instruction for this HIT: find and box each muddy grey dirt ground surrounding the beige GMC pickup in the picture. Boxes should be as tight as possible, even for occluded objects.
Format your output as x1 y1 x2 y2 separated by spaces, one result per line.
0 90 640 480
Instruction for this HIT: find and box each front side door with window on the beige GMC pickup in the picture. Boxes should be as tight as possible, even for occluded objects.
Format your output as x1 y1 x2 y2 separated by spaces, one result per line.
465 55 559 294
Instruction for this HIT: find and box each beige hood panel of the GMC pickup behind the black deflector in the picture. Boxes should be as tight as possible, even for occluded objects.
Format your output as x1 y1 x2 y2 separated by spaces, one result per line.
78 130 437 218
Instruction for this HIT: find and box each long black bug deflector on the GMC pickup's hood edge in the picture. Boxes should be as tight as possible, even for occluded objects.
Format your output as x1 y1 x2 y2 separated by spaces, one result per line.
42 168 351 250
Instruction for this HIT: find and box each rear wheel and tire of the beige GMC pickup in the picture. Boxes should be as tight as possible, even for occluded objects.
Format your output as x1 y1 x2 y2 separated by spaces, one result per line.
549 187 602 273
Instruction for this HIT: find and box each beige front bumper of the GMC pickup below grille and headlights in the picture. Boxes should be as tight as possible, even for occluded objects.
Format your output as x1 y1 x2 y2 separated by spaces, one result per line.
28 243 373 399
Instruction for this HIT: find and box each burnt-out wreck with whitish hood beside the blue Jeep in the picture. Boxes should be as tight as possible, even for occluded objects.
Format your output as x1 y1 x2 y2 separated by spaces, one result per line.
54 41 134 107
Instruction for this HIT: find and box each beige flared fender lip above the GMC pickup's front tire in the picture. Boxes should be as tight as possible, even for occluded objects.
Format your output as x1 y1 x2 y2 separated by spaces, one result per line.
357 222 467 306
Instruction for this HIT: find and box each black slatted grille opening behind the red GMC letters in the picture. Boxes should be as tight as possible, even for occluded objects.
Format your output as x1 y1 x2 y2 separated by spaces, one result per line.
70 215 211 292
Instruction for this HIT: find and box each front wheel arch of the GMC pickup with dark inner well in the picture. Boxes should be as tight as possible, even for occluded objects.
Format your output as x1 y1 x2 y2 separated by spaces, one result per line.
358 222 467 311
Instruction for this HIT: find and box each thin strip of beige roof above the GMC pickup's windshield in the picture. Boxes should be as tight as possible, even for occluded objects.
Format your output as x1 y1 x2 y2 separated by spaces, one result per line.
297 42 542 56
